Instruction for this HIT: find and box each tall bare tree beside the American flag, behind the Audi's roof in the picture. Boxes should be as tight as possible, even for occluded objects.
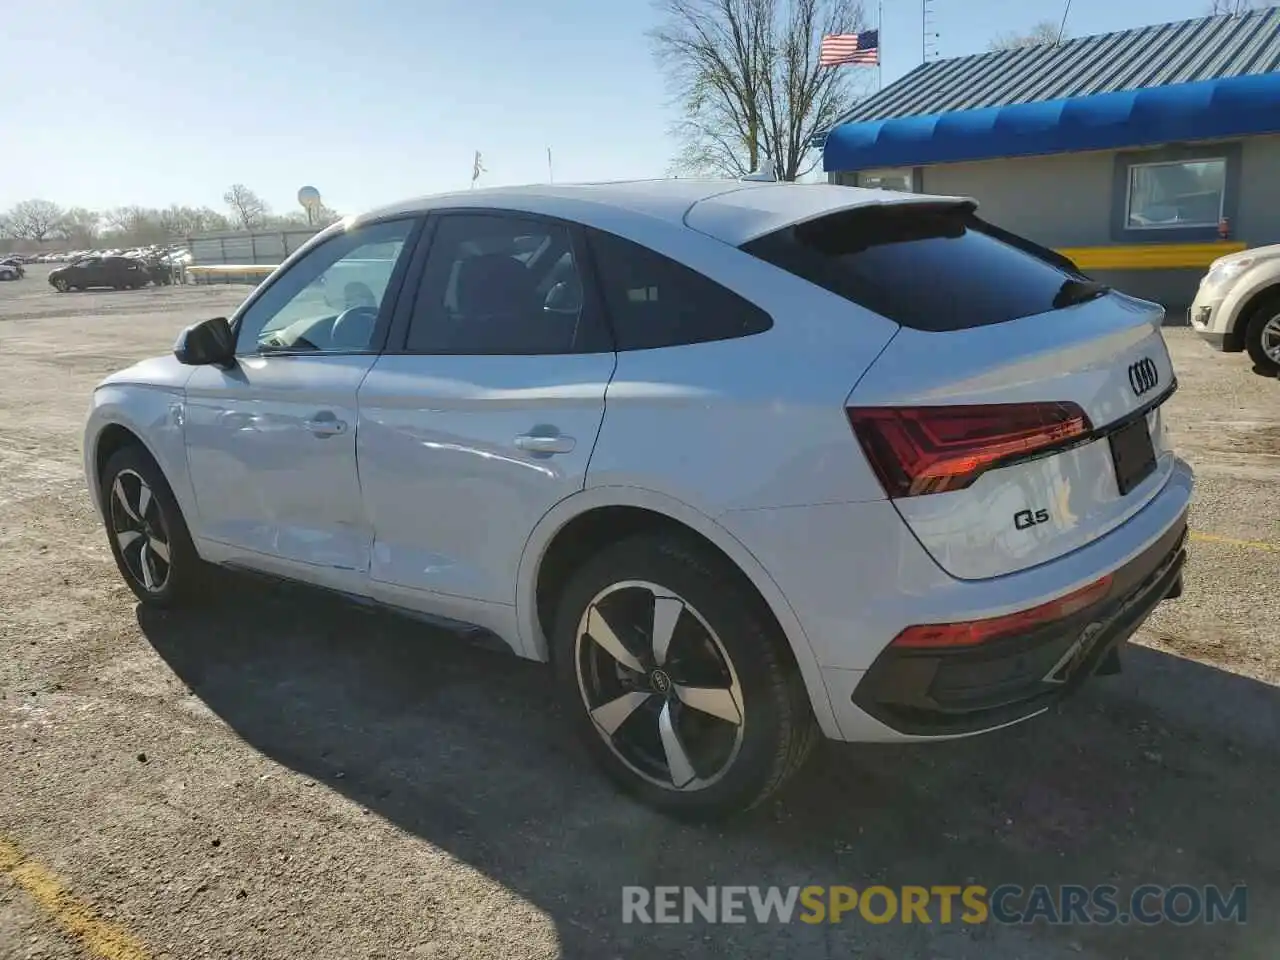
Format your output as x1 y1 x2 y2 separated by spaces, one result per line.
649 0 864 180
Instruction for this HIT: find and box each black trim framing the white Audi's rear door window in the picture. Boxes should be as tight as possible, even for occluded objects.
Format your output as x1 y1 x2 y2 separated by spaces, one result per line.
383 206 617 357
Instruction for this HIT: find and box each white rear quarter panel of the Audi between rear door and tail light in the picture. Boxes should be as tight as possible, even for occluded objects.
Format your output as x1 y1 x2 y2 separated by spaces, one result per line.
588 224 897 516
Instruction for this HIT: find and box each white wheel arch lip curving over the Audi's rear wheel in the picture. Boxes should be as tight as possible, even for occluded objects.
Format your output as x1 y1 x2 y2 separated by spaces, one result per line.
516 486 840 737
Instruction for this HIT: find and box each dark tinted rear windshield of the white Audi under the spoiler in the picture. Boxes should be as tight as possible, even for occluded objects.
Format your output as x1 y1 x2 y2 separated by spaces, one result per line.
742 204 1080 332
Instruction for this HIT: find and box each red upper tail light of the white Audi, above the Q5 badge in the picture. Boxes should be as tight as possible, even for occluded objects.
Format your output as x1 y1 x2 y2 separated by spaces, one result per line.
845 403 1093 499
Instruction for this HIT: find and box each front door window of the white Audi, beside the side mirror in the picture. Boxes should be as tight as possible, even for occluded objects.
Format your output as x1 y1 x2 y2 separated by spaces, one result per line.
236 220 415 355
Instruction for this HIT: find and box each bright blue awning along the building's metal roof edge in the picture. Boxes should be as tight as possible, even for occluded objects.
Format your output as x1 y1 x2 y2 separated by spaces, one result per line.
822 73 1280 172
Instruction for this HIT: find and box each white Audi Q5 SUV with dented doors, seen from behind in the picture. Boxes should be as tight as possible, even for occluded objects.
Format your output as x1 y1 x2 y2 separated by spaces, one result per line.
84 180 1192 815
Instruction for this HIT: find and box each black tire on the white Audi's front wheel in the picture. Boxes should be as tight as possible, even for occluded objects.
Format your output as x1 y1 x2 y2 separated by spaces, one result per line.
101 444 205 607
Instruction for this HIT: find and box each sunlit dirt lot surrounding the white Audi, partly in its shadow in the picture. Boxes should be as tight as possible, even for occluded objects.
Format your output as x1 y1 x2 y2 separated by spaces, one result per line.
0 268 1280 960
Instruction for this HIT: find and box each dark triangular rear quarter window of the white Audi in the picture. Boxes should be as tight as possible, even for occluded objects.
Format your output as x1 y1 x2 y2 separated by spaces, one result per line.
588 230 773 349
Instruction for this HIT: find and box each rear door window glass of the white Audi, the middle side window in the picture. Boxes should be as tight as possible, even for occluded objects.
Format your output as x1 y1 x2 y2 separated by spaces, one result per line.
404 214 608 356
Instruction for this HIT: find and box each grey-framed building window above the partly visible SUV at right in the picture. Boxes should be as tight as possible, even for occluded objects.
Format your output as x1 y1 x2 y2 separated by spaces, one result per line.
1125 156 1226 230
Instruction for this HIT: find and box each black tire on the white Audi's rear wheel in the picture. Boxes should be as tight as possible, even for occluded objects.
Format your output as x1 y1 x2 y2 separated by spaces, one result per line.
552 534 819 820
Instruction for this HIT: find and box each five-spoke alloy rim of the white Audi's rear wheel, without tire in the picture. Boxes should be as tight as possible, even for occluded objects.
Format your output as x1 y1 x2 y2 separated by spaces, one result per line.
575 580 746 791
